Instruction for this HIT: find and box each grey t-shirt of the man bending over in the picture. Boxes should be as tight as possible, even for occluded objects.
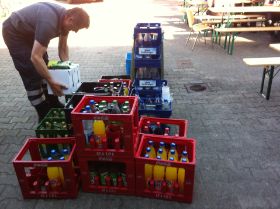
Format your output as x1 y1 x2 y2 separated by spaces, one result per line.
10 2 66 47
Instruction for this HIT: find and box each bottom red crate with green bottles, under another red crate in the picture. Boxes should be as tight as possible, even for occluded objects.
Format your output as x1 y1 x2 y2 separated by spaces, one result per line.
79 156 135 195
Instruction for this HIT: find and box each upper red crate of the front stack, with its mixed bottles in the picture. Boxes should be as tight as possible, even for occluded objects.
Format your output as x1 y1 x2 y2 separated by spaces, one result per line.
71 95 139 160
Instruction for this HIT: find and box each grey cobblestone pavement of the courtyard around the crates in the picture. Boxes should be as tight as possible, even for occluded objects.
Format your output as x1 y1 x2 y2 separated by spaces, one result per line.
0 0 280 209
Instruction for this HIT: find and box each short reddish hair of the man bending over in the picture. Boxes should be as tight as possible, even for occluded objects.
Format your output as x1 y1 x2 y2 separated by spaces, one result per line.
65 7 90 28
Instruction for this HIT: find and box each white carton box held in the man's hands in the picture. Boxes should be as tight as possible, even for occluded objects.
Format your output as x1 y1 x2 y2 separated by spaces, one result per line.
47 64 81 95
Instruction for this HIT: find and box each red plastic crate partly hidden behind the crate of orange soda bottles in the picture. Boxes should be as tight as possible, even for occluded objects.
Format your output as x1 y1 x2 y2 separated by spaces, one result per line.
139 116 188 137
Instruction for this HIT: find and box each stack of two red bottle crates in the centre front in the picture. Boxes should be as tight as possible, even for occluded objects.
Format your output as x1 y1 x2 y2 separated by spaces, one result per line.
71 95 138 195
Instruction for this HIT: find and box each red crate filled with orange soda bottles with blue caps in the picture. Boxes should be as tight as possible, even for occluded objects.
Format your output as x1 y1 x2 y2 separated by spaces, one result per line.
135 134 196 203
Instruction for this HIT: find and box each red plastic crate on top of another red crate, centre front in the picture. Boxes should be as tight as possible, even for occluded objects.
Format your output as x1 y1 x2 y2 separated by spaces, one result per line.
71 95 138 158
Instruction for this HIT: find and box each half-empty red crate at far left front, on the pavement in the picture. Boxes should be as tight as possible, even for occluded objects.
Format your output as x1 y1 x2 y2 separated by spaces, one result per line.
13 137 79 199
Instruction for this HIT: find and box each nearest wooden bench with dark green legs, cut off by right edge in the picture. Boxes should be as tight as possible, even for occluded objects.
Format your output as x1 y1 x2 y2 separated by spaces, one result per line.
243 57 280 100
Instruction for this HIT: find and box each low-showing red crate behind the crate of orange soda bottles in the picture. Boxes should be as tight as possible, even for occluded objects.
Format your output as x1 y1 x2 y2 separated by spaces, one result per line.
139 116 188 137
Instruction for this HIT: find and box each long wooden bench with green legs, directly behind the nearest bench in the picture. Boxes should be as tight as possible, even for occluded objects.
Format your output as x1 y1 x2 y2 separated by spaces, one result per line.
213 26 280 54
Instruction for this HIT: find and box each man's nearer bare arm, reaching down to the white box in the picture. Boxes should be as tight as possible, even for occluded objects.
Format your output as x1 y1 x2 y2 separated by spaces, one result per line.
31 40 66 96
